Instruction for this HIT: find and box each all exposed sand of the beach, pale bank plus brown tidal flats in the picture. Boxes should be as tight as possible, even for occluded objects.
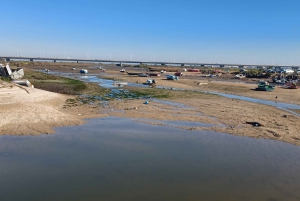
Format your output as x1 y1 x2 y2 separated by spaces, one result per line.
0 65 300 145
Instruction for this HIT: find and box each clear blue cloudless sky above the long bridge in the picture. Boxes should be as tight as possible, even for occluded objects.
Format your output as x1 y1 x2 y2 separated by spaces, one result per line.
0 0 300 65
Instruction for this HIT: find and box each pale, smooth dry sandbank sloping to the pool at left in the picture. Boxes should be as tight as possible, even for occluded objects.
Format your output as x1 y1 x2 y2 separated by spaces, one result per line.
0 81 104 135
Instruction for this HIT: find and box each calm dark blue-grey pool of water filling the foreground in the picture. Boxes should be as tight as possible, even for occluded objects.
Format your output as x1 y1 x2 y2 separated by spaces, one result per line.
0 117 300 201
